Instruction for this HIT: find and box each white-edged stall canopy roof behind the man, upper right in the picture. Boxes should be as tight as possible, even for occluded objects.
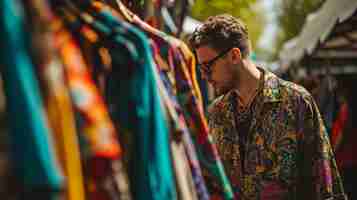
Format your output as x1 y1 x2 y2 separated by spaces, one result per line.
279 0 357 75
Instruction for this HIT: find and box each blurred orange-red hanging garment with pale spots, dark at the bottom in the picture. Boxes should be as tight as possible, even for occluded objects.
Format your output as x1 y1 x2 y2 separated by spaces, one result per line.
57 26 131 200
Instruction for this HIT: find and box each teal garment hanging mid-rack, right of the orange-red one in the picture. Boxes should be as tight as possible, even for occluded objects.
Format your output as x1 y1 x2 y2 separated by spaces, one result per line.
77 9 176 200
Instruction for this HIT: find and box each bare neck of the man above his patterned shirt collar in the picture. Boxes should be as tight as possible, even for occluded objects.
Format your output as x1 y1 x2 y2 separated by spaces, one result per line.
235 59 261 103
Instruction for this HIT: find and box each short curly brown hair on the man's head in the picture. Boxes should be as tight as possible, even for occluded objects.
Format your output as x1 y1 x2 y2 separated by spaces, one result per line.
189 14 250 58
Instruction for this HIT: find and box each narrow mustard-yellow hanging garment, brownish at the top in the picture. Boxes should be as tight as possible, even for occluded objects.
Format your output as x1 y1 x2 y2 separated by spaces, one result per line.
27 1 85 200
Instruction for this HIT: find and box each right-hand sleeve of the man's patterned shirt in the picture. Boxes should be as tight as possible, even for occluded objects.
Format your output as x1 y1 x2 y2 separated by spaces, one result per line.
297 95 347 200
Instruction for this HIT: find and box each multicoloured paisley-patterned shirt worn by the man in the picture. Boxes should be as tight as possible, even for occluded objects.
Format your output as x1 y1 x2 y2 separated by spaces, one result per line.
208 68 346 200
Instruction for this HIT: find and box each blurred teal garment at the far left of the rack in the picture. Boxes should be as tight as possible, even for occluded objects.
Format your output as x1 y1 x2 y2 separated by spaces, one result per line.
0 0 64 199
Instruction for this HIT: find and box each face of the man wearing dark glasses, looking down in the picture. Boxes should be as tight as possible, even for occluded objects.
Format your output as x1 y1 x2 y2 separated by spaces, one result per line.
196 46 237 95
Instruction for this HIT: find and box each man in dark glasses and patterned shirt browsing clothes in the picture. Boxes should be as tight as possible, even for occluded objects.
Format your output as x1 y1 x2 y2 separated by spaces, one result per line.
190 14 347 200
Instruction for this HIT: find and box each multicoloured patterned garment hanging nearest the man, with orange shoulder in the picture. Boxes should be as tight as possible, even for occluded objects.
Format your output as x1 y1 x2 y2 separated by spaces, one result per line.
129 16 233 199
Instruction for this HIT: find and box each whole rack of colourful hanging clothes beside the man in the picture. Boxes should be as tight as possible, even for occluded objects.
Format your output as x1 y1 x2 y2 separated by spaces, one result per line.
0 0 233 200
